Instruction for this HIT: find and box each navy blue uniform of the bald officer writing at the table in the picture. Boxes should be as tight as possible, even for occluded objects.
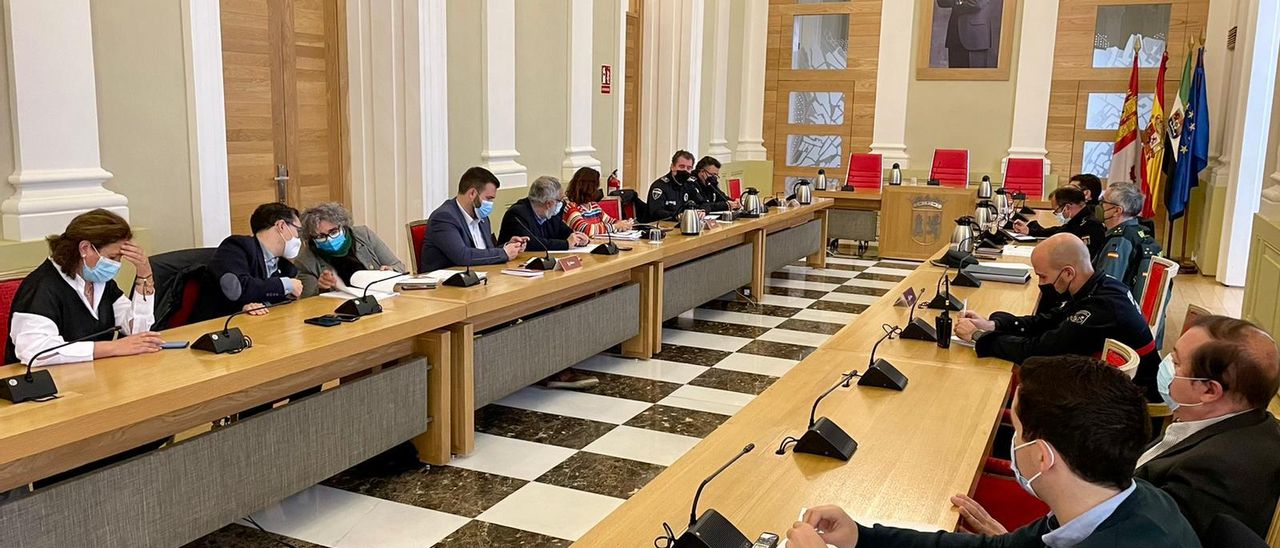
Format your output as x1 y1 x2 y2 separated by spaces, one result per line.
974 273 1160 402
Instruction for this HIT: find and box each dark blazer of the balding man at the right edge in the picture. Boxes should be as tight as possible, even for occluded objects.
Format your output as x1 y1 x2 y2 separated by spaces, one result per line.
1135 410 1280 538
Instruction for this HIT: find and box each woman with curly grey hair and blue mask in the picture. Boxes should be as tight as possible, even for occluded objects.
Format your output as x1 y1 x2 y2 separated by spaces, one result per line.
296 202 404 297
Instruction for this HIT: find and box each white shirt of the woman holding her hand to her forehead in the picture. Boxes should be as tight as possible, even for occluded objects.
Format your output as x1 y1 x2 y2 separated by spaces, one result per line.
9 258 155 367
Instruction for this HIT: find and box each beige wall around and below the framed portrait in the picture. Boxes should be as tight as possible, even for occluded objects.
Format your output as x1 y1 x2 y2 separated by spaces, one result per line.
906 0 1024 173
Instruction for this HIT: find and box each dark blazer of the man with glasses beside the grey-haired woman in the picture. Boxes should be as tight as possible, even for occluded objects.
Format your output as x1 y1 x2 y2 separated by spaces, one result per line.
209 236 298 314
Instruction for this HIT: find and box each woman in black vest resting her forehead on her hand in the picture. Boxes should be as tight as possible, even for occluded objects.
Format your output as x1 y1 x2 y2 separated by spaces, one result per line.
5 209 163 366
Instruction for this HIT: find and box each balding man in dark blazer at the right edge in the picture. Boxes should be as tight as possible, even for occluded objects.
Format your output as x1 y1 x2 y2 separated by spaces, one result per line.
951 316 1280 542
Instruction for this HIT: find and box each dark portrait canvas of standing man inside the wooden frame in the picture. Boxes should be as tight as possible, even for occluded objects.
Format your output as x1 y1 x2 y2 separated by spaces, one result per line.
937 0 1005 68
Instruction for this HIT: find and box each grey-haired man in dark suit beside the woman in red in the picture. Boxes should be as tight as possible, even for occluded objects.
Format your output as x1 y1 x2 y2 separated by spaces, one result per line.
498 175 591 251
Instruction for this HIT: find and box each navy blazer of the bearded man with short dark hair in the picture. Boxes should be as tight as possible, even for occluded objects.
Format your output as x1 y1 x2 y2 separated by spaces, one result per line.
417 198 507 273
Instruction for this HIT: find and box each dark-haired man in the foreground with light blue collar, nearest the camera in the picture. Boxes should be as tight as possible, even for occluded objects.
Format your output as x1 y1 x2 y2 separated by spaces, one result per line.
787 356 1201 548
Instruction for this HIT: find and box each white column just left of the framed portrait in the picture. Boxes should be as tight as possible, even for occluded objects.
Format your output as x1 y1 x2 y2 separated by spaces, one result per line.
865 0 918 169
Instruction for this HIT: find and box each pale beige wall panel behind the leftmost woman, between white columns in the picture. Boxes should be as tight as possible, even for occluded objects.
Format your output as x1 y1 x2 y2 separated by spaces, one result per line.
90 0 195 254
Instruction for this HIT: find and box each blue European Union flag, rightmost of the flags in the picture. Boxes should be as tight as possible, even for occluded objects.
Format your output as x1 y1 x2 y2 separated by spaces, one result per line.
1165 47 1208 220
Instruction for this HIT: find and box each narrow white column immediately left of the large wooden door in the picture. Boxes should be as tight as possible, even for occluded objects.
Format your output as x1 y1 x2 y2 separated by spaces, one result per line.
182 0 232 247
